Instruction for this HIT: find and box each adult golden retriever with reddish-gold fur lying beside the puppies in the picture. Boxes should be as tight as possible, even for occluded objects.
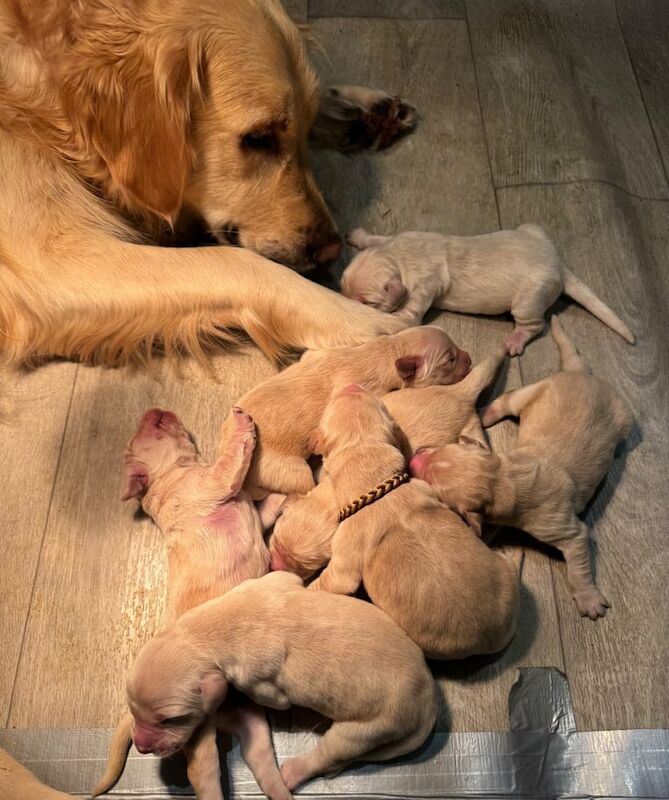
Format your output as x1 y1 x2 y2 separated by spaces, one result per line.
0 0 412 363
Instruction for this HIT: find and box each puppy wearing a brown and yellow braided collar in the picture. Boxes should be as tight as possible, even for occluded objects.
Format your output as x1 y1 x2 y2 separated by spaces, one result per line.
309 385 519 658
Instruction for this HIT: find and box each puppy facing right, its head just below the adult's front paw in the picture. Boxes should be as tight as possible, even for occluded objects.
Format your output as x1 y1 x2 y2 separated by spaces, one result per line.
238 326 471 499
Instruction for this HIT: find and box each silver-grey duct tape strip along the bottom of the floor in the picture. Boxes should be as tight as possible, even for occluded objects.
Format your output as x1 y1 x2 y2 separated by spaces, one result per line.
0 669 669 800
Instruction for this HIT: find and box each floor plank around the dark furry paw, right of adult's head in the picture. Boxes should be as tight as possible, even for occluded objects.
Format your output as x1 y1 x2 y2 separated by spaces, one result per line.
311 18 497 276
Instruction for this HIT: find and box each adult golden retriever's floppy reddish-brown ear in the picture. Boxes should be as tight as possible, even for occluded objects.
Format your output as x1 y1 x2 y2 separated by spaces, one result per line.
64 35 199 223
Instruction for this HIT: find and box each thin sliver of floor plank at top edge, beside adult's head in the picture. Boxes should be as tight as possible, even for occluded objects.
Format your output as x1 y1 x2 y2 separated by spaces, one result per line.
309 0 465 19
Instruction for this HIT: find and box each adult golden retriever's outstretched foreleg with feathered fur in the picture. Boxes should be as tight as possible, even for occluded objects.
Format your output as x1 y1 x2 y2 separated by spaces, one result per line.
0 237 405 364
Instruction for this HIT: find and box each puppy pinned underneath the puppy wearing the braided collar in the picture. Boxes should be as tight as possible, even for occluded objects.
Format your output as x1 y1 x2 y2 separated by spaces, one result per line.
269 353 503 579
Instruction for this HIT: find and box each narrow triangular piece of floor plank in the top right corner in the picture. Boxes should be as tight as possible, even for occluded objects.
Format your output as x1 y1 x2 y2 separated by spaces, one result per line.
618 0 669 174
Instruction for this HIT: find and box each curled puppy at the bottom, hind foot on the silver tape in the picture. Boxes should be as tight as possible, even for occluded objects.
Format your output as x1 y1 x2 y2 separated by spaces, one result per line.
128 572 436 789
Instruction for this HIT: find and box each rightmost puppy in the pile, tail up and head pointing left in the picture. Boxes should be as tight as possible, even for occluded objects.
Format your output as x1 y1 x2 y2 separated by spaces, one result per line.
410 317 633 619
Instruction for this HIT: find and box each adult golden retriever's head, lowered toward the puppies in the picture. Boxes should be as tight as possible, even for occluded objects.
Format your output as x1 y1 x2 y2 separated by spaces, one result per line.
11 0 340 269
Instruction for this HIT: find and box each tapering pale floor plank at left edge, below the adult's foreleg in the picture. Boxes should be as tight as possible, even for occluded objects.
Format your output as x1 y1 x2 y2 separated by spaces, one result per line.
0 363 76 726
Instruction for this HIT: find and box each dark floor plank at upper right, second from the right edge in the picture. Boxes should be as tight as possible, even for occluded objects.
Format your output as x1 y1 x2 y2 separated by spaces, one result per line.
467 0 669 198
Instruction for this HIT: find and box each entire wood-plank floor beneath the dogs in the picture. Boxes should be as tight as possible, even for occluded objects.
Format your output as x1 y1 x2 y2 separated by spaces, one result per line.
0 0 669 731
